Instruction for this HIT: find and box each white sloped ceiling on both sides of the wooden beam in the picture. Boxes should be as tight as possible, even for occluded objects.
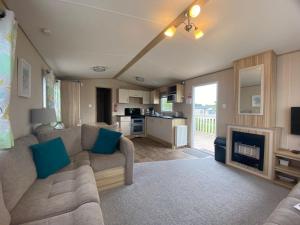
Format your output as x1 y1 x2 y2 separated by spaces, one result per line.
6 0 300 87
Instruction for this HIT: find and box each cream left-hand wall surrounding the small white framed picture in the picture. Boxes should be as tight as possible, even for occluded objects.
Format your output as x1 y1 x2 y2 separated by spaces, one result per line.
10 19 49 138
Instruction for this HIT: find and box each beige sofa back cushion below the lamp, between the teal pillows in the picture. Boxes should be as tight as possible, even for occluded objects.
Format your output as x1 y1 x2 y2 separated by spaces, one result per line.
37 127 82 156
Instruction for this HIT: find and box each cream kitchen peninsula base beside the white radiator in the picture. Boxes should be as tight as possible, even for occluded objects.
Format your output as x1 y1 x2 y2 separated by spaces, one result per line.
146 116 186 148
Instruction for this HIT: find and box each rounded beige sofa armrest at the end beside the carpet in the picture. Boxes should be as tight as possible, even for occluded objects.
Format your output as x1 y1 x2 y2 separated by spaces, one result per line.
120 137 134 185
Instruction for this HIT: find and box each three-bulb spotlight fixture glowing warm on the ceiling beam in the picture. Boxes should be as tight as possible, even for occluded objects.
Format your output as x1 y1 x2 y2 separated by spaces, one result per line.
164 4 204 39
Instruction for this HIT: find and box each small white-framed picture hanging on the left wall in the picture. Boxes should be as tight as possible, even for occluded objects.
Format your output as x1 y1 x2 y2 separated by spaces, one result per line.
18 58 31 98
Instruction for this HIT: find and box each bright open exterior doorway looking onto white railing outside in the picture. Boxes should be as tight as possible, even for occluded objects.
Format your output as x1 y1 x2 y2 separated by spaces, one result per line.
192 83 218 154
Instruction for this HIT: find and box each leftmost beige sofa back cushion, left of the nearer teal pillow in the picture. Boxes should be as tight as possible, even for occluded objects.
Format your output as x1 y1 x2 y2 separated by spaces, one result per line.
0 135 38 212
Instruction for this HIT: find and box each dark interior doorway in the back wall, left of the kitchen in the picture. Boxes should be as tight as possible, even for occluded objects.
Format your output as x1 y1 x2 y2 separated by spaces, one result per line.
96 88 112 124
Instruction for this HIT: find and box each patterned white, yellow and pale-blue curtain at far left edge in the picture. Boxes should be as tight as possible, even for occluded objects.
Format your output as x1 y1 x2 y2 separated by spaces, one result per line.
0 10 17 149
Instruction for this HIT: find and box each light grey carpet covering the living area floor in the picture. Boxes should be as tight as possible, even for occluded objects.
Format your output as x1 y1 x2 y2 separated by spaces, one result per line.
100 158 288 225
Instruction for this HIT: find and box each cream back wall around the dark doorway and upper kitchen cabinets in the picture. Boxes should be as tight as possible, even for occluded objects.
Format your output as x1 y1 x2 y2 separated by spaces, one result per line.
80 79 150 123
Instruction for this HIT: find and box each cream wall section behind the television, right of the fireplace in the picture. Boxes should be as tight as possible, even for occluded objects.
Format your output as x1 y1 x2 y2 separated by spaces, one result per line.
276 51 300 149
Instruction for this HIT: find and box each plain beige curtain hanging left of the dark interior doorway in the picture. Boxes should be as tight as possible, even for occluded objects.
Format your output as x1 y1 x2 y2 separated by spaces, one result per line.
61 81 81 128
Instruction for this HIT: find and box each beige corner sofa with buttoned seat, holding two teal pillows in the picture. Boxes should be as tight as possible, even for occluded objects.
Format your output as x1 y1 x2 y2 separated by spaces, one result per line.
0 125 134 225
